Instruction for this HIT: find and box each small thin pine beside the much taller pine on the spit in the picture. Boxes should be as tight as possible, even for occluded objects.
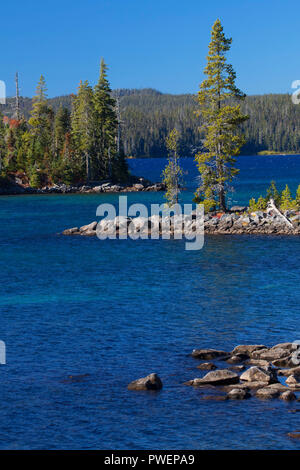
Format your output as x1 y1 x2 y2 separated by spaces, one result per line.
162 129 183 207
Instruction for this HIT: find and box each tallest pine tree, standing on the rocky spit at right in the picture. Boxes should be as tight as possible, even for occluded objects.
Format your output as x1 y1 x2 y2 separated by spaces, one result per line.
196 19 248 211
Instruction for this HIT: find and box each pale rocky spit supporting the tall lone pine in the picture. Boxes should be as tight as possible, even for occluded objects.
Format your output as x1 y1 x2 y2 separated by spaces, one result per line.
62 206 300 238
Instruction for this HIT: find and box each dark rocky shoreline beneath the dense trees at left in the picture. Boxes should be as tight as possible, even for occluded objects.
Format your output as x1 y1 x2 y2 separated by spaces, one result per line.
0 176 165 196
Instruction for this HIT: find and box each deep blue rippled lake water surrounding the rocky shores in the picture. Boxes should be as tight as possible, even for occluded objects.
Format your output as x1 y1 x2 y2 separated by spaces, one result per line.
0 157 300 449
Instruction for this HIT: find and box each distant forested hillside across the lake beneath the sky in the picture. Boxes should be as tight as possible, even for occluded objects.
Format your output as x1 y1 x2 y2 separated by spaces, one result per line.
1 89 300 157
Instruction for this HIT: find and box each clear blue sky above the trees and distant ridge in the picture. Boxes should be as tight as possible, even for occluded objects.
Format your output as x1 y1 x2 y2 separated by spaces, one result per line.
0 0 300 97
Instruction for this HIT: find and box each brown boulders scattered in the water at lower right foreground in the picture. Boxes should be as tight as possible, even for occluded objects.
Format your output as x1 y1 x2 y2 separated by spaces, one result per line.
128 343 300 401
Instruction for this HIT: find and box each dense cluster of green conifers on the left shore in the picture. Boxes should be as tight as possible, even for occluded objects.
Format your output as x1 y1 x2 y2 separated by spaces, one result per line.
0 60 129 188
